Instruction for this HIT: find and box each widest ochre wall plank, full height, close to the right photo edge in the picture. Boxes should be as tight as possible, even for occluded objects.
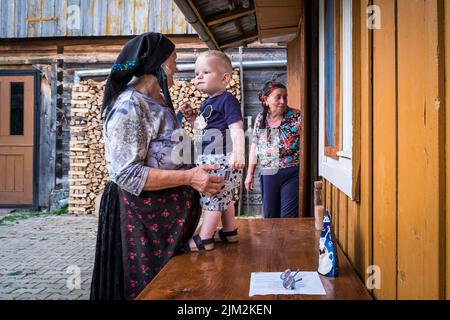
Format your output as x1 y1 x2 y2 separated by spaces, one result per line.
397 0 444 299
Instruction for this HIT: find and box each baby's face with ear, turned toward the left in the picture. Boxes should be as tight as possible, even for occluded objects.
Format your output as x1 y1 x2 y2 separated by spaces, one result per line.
194 57 230 96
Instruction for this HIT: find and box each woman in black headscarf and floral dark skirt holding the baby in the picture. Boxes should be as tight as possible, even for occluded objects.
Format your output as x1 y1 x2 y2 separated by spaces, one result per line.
91 33 223 299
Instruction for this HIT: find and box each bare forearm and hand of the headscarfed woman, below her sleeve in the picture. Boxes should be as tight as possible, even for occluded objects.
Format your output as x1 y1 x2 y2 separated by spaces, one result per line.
143 165 224 197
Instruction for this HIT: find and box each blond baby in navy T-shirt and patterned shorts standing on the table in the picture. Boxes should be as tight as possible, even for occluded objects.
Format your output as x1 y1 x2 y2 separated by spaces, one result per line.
181 50 245 251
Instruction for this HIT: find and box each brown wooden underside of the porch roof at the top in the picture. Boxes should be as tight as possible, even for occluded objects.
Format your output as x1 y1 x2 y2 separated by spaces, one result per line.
175 0 304 50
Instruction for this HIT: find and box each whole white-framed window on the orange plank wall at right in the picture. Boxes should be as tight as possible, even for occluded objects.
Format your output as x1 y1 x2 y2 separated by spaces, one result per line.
319 0 353 199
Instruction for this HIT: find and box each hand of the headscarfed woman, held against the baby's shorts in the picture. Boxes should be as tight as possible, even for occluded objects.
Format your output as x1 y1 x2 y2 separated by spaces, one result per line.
189 165 224 197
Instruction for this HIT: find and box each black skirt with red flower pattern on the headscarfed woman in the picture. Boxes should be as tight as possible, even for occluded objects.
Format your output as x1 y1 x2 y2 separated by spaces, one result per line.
91 182 201 300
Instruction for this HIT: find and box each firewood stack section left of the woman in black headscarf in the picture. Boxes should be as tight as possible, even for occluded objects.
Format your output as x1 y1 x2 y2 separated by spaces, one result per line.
69 80 108 214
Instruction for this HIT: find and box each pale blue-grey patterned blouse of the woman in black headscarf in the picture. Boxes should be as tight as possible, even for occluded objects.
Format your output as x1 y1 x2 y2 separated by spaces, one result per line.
103 87 185 196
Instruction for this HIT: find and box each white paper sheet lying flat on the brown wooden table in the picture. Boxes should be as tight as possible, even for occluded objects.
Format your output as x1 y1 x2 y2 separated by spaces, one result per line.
249 272 326 297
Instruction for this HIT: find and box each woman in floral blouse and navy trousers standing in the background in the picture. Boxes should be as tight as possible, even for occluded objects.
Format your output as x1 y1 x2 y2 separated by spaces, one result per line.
245 81 301 218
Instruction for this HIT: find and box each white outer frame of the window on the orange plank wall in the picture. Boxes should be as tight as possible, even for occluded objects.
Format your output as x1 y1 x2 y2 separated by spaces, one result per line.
318 0 357 200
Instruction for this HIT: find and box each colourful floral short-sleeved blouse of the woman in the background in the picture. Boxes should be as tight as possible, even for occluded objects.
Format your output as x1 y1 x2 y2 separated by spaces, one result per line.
253 107 301 169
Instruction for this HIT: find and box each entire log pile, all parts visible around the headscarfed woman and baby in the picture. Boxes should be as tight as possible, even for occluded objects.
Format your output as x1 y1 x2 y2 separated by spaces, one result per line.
69 68 241 215
